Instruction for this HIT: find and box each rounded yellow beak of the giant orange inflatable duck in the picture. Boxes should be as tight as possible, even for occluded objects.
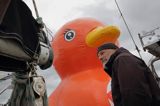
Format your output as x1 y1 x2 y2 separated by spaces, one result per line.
85 26 120 47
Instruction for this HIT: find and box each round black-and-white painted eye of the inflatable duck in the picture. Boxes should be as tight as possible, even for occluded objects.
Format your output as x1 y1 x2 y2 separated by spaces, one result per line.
64 30 76 41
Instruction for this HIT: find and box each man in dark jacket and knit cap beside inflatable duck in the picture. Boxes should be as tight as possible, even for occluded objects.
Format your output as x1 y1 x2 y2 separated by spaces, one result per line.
97 43 160 106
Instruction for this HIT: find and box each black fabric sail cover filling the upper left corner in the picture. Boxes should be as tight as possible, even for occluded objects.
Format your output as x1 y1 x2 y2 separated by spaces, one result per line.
0 0 40 71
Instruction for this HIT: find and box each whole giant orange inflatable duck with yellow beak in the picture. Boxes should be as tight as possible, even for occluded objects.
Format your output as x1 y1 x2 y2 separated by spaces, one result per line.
49 18 120 106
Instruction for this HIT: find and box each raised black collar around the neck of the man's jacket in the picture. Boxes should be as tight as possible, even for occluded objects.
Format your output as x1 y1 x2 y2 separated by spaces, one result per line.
104 47 130 76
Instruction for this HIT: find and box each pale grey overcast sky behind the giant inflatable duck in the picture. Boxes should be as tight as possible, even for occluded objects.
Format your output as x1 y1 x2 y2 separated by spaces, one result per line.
0 0 160 99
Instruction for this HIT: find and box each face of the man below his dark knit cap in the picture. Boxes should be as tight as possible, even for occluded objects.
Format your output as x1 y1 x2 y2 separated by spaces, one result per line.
98 49 116 67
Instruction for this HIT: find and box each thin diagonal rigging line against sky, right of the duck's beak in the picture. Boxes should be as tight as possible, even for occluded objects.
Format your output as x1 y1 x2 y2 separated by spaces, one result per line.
115 0 142 59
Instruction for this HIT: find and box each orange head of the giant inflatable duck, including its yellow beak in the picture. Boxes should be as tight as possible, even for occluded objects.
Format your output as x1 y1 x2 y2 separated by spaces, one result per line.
52 18 120 79
